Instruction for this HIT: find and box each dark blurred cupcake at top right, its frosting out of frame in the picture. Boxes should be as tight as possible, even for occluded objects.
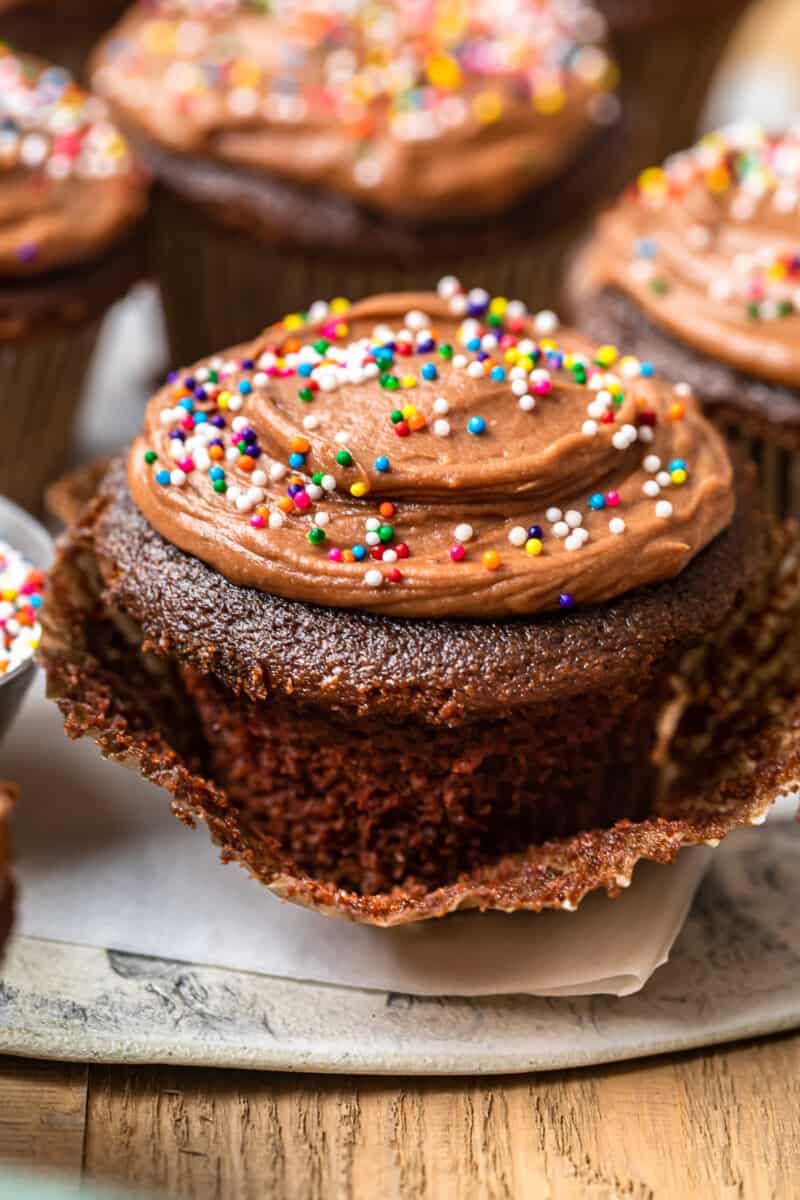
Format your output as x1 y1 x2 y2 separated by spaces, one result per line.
595 0 750 174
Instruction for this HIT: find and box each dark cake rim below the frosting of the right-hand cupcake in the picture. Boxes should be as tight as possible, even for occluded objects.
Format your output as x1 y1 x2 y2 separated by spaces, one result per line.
573 288 800 450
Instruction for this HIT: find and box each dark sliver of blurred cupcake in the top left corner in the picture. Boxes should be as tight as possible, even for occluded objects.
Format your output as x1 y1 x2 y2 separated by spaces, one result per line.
0 0 126 76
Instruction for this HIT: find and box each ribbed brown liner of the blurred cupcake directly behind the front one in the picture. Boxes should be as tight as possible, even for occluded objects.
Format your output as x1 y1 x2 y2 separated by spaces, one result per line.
154 182 587 365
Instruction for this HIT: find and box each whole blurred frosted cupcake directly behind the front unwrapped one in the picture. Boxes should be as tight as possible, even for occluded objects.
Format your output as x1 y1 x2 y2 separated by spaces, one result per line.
94 0 622 364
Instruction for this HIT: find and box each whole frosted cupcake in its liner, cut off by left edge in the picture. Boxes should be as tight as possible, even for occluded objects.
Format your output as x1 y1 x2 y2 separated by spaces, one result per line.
0 44 148 508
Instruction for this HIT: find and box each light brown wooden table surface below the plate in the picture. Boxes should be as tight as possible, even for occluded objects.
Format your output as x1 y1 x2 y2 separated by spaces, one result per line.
0 1034 800 1200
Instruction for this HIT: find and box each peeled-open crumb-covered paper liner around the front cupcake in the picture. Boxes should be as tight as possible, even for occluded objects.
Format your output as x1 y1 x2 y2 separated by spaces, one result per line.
42 496 800 926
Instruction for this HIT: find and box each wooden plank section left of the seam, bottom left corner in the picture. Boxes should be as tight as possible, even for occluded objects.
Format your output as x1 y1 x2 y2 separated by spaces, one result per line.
0 1058 89 1178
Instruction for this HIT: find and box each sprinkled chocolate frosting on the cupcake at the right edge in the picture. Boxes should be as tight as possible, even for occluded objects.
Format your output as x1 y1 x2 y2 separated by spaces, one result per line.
576 126 800 385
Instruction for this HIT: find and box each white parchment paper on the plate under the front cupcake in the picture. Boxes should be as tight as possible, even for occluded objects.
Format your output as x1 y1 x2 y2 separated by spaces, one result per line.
0 678 711 996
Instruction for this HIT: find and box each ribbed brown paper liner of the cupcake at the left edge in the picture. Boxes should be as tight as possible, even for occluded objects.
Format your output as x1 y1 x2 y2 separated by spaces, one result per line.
0 318 101 510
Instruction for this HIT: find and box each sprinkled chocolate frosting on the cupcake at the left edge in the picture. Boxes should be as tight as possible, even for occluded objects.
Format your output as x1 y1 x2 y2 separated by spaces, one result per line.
0 42 146 277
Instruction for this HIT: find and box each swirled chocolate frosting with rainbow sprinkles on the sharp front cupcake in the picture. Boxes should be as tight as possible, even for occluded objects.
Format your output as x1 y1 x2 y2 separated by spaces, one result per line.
128 278 734 618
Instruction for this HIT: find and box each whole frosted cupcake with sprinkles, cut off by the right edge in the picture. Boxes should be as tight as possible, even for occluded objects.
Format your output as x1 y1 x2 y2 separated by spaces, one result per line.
572 126 800 515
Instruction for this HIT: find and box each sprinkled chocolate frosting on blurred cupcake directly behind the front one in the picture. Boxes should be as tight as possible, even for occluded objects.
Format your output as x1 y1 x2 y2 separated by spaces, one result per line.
95 0 618 220
